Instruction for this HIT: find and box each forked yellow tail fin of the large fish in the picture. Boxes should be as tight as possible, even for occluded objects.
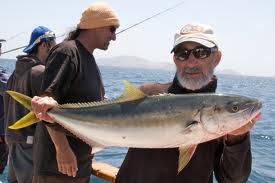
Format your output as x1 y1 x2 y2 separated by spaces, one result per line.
7 90 40 129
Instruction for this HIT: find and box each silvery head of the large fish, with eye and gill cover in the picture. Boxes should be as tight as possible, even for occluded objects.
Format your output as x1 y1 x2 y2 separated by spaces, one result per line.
199 94 262 136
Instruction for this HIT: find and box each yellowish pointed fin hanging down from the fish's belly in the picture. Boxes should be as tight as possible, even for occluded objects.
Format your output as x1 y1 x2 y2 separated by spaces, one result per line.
178 145 197 174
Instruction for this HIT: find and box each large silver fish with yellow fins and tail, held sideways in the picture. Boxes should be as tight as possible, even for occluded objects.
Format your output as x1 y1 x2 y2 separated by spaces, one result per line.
5 81 262 172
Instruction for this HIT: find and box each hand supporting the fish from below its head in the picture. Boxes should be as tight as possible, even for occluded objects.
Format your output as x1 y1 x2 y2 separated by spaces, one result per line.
225 113 261 145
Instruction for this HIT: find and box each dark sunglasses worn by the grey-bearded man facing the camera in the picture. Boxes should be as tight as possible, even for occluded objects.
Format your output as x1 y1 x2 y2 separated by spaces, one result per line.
175 47 217 62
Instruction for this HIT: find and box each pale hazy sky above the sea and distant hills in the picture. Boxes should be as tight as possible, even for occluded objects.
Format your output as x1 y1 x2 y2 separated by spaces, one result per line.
0 0 275 76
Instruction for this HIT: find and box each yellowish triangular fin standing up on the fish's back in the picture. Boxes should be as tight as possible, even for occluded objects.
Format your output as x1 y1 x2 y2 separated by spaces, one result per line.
115 80 146 102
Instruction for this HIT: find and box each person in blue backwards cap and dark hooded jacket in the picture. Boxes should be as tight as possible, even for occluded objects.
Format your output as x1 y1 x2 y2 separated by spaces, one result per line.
4 26 56 183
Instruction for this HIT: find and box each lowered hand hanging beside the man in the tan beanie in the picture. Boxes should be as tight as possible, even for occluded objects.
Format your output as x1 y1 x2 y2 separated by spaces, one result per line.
56 147 78 177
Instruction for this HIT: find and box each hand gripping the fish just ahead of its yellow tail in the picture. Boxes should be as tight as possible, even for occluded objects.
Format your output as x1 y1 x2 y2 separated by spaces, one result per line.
31 96 58 123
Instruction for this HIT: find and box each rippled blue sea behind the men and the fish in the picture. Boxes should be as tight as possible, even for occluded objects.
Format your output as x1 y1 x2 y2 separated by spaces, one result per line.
0 61 275 183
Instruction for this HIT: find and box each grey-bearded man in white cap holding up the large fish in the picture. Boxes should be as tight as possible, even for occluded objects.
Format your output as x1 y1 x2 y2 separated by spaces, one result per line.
116 23 259 183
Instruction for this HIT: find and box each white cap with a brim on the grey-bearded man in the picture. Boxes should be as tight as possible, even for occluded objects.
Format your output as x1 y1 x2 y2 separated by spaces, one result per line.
171 23 218 53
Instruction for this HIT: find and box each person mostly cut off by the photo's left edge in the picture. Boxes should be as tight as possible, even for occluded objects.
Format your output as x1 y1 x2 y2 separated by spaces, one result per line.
0 39 8 174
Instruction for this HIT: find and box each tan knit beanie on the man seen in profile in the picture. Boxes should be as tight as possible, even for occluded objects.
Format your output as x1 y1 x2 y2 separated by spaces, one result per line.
77 2 119 29
